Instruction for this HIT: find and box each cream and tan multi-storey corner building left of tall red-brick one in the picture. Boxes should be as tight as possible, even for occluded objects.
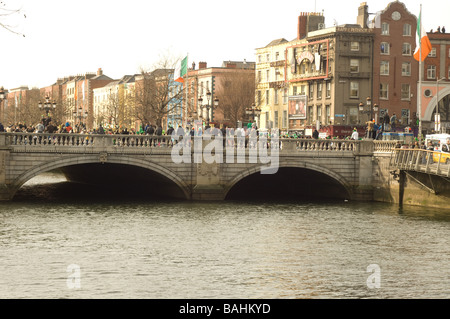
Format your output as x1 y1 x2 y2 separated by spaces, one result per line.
255 14 373 135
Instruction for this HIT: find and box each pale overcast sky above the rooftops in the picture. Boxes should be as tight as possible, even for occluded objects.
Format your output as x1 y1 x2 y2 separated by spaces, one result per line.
0 0 450 89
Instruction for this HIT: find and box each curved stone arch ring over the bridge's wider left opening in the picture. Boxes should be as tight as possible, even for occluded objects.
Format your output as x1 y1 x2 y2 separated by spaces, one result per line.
9 154 191 199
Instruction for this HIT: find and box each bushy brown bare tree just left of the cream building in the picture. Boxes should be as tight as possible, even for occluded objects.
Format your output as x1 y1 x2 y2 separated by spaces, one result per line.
216 72 255 124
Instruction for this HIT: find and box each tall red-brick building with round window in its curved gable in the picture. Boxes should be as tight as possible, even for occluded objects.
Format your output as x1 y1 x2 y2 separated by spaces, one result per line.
370 1 419 126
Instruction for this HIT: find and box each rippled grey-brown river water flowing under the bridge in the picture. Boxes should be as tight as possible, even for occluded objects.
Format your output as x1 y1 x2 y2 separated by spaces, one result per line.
0 174 450 299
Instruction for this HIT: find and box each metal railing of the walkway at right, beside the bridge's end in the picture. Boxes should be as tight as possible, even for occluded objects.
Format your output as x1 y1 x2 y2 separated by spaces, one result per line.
390 149 450 177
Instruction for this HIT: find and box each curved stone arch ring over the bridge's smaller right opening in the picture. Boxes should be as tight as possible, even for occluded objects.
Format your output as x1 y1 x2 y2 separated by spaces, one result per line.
224 161 353 199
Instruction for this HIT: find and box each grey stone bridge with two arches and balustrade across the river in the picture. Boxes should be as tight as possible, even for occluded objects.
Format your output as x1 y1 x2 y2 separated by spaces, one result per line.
0 133 393 200
